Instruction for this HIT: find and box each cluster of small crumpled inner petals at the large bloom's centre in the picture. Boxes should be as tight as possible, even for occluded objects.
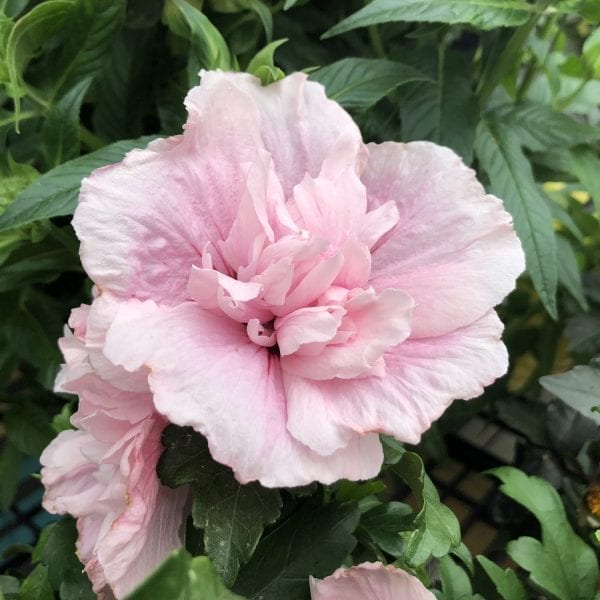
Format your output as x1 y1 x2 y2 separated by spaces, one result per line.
188 155 412 379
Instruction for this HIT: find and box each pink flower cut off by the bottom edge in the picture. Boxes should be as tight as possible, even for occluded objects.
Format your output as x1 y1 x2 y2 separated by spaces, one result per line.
310 562 435 600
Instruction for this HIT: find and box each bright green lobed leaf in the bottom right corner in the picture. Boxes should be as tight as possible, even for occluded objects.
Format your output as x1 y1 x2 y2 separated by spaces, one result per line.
490 467 598 600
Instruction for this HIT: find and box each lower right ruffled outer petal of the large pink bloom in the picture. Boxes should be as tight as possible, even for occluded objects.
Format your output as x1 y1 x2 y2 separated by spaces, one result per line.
284 311 508 453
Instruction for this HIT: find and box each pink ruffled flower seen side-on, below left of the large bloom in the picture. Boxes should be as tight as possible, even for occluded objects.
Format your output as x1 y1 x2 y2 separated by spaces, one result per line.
41 296 187 599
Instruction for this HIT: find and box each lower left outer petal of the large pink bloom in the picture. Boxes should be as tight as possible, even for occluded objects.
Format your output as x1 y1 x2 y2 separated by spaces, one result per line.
105 301 382 487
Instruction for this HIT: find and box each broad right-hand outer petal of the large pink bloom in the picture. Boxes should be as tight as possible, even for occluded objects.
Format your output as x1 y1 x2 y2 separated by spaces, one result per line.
362 142 524 337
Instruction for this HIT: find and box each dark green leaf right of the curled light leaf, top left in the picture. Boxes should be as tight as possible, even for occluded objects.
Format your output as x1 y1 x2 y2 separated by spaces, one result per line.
47 0 125 102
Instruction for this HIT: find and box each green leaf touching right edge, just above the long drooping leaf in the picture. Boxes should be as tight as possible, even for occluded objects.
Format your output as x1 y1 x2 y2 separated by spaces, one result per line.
494 102 600 152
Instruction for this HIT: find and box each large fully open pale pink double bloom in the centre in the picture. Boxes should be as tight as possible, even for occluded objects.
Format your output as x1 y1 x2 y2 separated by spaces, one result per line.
69 72 523 486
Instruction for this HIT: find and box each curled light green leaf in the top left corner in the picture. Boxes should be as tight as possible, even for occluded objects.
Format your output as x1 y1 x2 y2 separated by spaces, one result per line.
6 0 75 122
